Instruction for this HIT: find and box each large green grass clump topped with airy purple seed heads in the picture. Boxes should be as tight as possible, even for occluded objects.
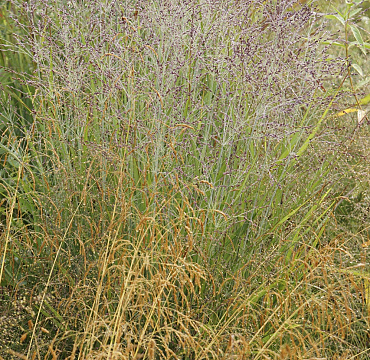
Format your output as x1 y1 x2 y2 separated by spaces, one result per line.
19 1 341 251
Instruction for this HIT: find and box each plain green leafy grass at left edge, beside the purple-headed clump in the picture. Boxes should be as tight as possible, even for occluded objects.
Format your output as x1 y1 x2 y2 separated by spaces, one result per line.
0 2 34 231
